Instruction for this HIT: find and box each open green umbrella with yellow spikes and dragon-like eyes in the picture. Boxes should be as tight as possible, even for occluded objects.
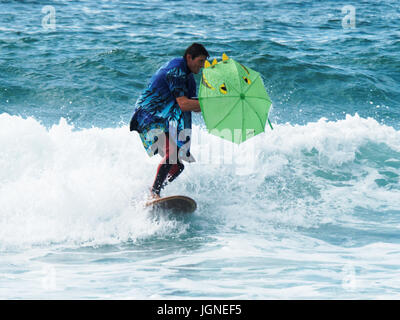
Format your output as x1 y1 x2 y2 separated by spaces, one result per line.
199 54 272 143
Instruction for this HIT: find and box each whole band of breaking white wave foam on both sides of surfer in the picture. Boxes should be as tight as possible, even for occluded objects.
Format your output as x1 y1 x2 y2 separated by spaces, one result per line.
0 114 400 247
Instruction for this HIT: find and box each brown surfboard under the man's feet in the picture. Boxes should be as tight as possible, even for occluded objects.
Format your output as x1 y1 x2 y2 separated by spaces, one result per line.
146 196 197 213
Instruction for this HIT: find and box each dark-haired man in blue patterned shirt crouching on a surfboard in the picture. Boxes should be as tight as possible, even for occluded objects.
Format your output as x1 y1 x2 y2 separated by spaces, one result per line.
130 43 209 199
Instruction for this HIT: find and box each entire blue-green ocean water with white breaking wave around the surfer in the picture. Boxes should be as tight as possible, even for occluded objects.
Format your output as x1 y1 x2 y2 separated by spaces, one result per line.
0 0 400 299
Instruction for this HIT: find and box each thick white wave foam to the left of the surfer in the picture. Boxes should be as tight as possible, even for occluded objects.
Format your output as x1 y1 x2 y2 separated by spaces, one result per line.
0 114 186 246
